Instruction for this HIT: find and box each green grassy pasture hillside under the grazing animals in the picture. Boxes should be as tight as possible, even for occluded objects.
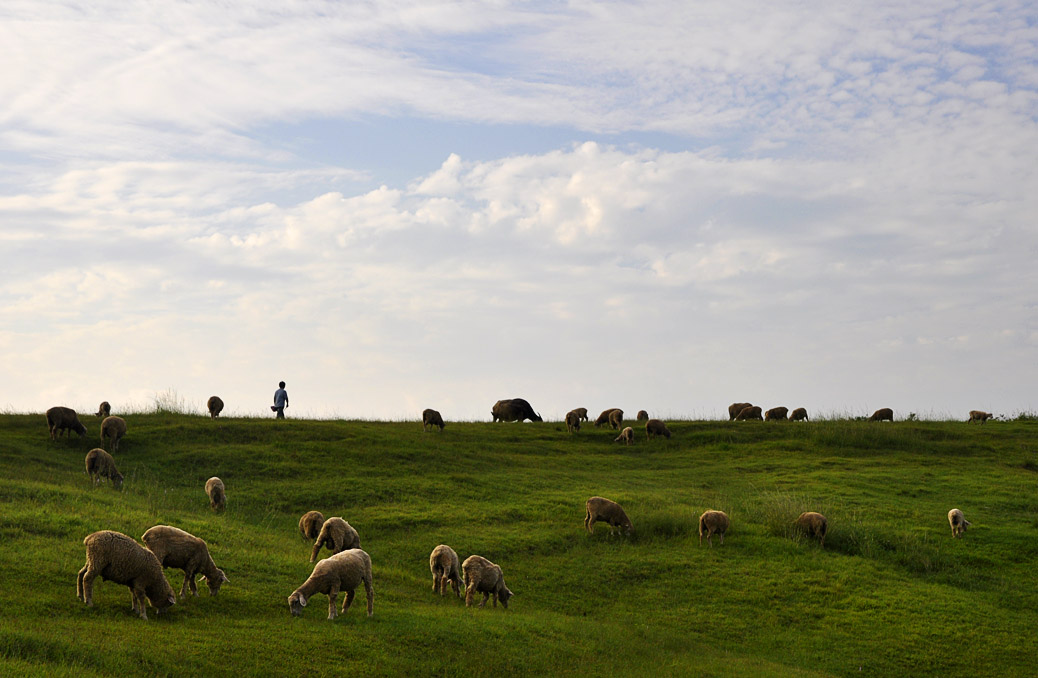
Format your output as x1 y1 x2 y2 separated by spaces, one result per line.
0 412 1038 678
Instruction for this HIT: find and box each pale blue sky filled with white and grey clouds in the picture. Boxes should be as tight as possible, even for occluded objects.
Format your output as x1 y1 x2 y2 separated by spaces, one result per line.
0 0 1038 423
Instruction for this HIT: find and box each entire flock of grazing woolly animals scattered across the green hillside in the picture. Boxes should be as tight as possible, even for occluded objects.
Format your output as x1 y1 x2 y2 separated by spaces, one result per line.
47 396 991 620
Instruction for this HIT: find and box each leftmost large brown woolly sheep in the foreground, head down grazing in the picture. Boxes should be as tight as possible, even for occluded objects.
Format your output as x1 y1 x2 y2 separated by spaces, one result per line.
76 530 176 620
